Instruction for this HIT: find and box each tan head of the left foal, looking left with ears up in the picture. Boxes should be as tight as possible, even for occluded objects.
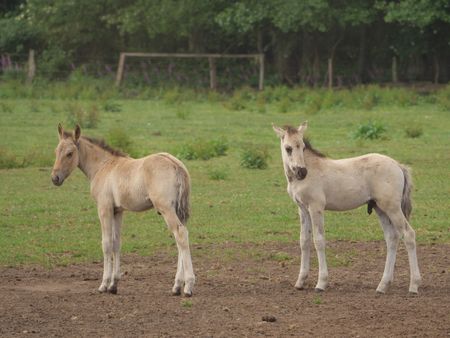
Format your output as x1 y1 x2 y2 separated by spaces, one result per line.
52 124 81 186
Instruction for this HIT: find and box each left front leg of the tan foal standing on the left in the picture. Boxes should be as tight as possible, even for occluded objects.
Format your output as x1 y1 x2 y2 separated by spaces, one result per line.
98 205 114 292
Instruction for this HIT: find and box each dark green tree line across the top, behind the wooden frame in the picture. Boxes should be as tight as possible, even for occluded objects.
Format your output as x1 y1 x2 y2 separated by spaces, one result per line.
0 0 450 85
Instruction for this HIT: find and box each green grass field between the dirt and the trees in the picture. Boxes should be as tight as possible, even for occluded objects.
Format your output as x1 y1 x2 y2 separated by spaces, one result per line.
0 87 450 267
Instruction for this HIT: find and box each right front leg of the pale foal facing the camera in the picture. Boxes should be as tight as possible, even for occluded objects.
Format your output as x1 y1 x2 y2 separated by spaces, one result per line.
309 207 328 291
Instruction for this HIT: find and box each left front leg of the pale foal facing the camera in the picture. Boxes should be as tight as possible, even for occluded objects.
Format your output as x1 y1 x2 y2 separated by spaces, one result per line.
295 206 311 290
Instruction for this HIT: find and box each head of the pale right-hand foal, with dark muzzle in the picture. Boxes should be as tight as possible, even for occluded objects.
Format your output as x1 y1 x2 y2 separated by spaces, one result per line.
272 121 308 180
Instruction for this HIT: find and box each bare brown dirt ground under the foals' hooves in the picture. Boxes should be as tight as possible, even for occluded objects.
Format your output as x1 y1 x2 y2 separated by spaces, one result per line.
0 241 450 337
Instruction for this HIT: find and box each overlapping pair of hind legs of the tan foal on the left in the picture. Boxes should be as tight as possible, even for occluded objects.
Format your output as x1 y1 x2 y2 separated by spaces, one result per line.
156 206 195 297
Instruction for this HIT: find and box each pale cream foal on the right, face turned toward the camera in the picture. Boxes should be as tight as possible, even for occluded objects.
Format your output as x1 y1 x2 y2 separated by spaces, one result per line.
273 122 421 293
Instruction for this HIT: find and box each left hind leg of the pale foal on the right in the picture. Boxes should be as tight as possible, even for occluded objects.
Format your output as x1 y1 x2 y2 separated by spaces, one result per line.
375 207 399 293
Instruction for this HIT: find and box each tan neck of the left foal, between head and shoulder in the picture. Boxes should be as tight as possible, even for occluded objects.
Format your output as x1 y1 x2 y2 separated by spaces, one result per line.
78 138 115 181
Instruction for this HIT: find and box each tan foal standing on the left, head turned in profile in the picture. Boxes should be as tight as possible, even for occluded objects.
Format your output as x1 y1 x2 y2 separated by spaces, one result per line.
52 124 195 297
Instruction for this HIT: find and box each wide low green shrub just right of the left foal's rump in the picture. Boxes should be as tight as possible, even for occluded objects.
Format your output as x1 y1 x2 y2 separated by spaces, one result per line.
178 139 228 160
